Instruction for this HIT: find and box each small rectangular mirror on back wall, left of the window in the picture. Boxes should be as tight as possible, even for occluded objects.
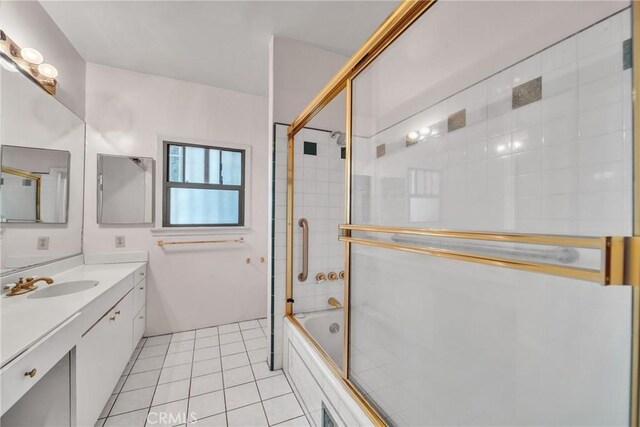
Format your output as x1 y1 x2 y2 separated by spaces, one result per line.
98 154 154 224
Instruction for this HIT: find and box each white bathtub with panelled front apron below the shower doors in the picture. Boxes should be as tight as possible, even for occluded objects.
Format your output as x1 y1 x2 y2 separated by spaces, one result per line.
283 309 374 427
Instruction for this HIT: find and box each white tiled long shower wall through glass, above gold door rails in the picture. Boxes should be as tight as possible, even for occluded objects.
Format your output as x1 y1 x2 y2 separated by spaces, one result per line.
353 9 632 235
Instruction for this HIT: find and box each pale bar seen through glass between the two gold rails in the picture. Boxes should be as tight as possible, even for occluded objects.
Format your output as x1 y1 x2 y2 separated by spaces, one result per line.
391 234 580 264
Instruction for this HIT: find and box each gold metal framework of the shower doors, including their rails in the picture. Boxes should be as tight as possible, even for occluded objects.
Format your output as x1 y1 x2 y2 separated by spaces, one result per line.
285 0 640 427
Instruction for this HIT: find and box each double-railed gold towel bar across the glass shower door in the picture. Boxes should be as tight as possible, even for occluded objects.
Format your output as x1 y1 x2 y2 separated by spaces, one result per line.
338 224 630 285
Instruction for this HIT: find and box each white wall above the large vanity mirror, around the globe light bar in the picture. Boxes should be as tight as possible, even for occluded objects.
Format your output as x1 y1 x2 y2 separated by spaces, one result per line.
0 0 86 118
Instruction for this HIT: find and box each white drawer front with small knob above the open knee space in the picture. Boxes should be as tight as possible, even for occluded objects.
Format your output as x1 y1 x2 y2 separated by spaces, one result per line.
0 313 81 414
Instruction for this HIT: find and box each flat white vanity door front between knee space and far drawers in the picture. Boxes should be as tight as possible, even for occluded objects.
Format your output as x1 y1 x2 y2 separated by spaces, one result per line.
76 292 135 426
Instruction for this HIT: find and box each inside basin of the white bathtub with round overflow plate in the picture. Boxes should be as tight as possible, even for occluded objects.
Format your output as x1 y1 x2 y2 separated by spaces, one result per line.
295 308 344 368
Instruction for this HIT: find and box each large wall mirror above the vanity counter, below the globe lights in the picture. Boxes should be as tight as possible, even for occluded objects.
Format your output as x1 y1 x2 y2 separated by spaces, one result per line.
0 68 85 275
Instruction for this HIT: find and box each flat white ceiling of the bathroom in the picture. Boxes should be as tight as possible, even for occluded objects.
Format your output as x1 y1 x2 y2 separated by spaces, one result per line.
41 0 398 96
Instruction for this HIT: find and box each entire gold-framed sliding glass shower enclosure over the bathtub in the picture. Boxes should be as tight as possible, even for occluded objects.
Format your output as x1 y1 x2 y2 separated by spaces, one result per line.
276 1 640 426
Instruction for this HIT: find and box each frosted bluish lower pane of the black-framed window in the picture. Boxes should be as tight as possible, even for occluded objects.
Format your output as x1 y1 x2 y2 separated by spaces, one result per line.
169 188 240 225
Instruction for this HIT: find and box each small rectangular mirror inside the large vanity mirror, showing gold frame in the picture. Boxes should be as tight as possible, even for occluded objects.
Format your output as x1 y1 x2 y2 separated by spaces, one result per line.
0 145 71 224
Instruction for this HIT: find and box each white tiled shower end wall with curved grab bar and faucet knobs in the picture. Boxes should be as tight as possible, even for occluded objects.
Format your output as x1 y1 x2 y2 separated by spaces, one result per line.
272 124 344 368
